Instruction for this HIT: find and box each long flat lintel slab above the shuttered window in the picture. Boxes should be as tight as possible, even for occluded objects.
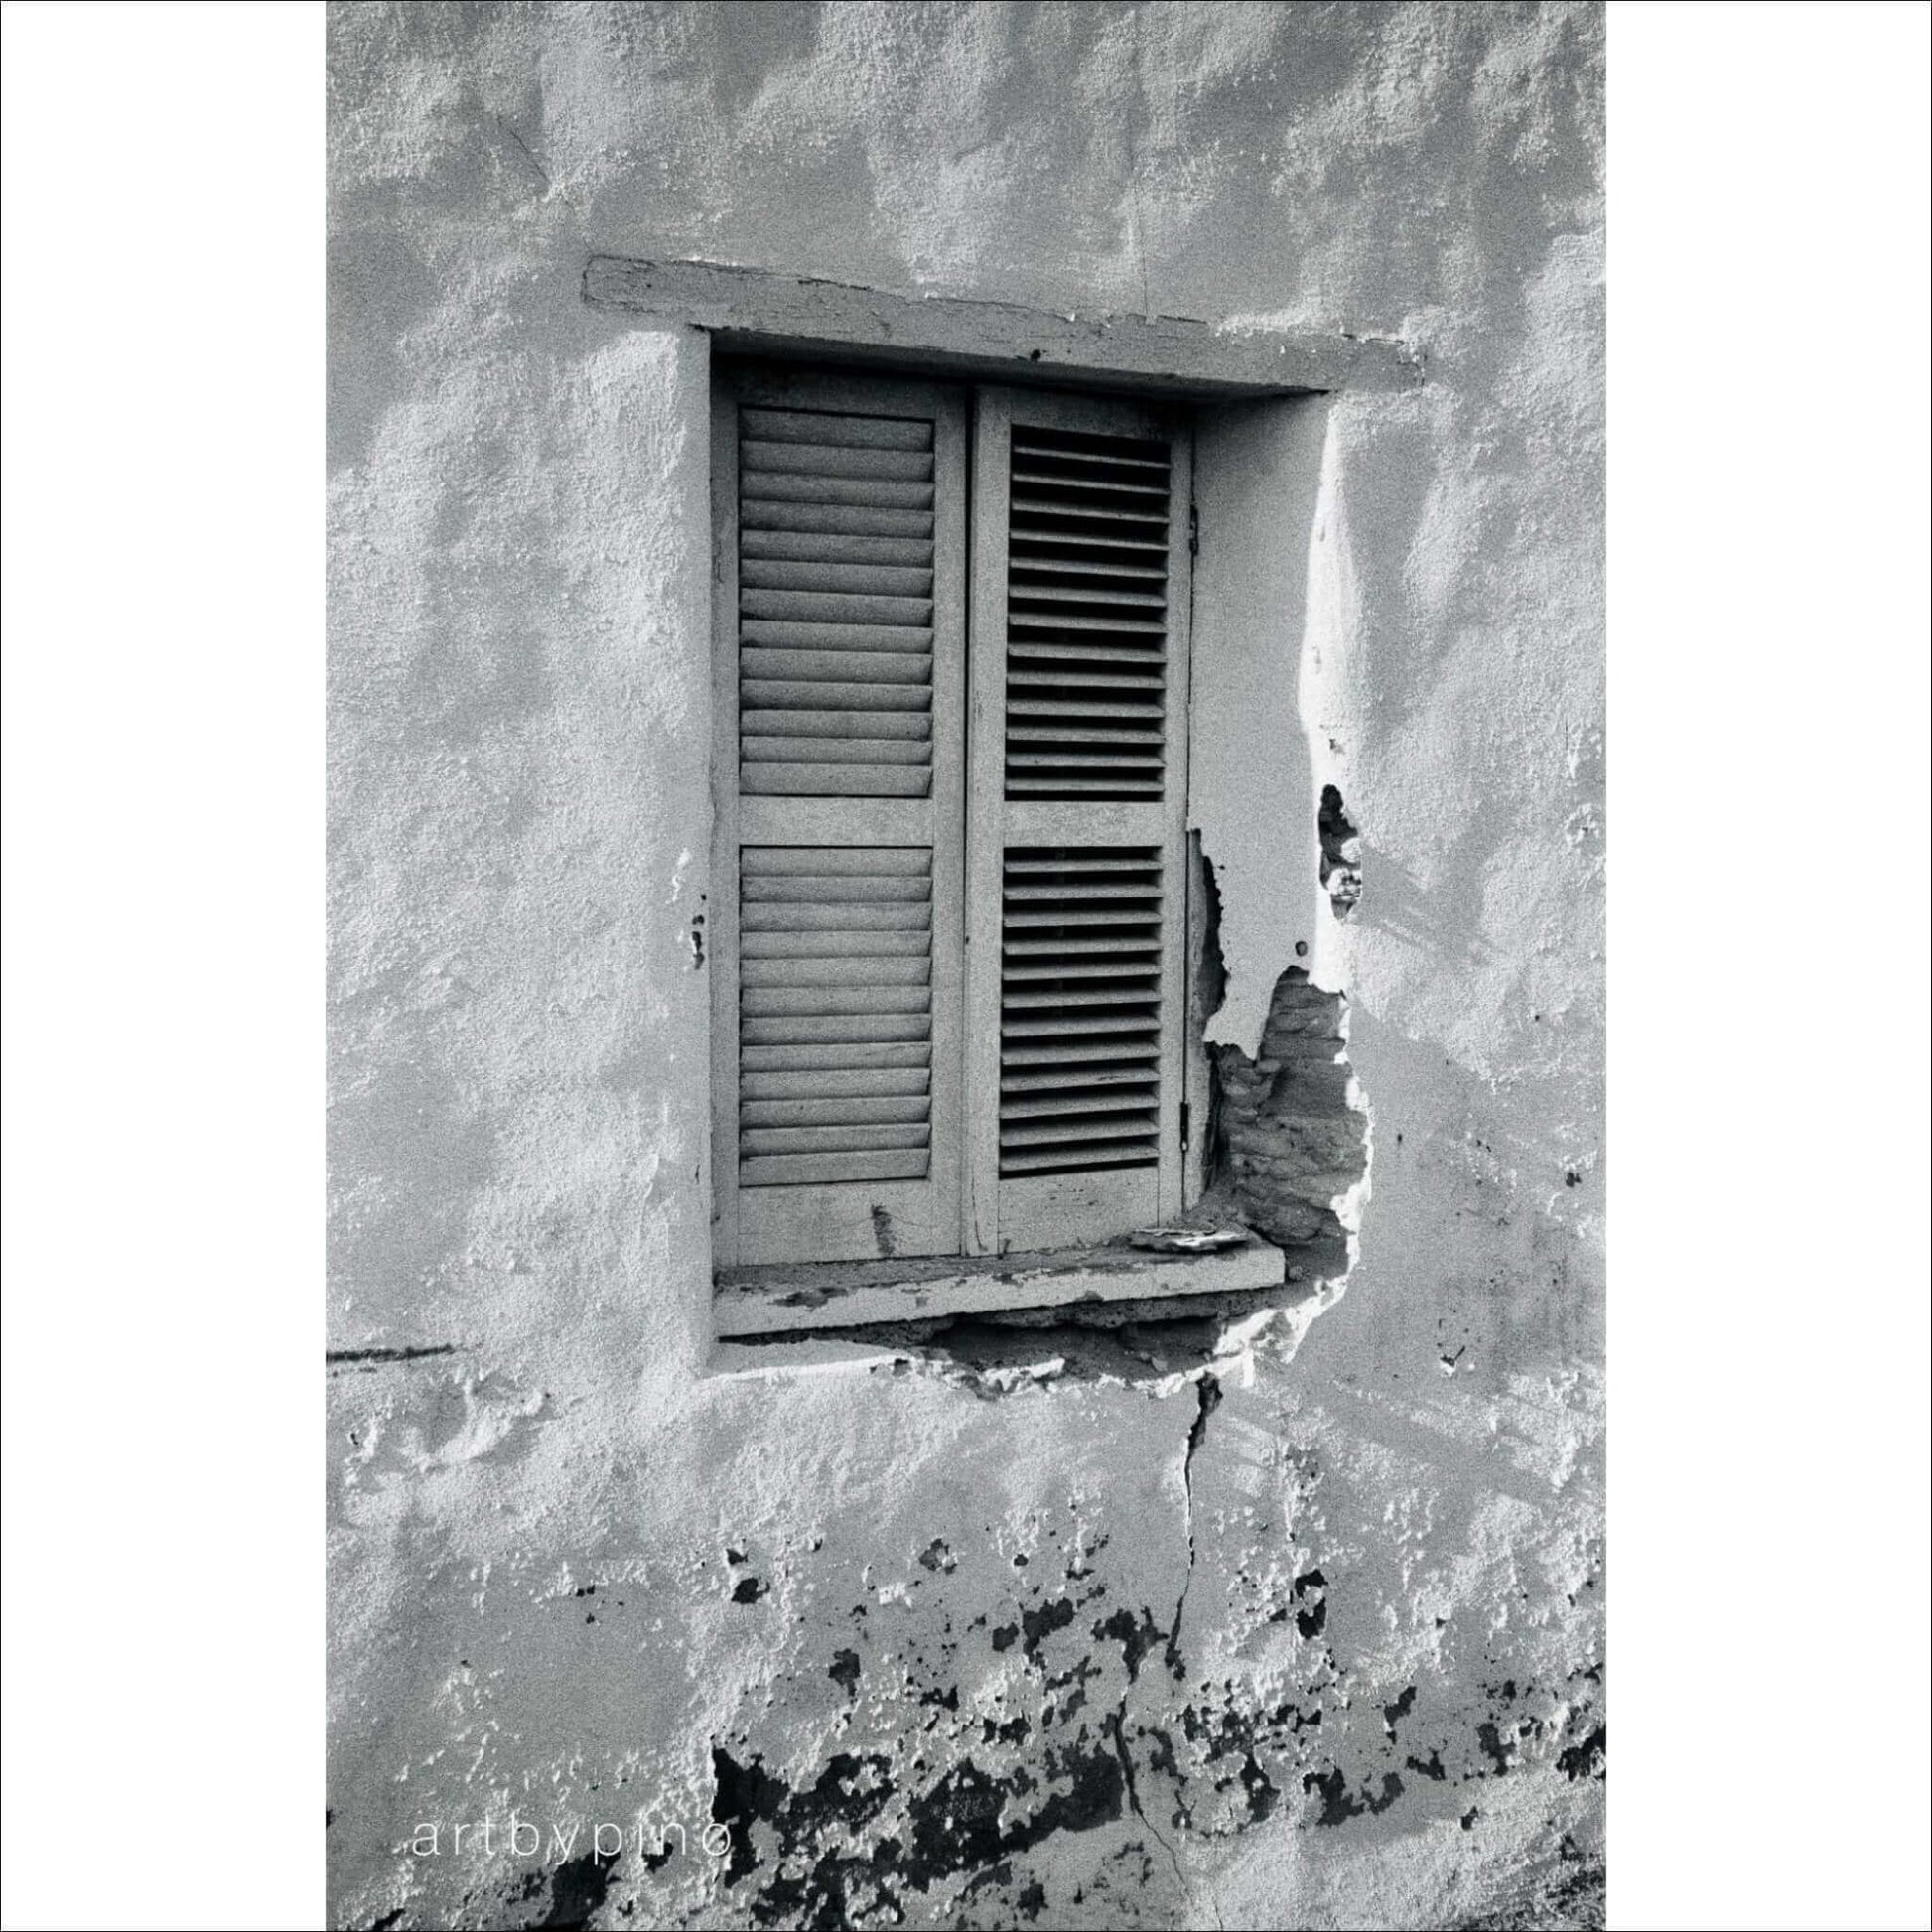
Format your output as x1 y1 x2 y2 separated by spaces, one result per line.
584 255 1422 402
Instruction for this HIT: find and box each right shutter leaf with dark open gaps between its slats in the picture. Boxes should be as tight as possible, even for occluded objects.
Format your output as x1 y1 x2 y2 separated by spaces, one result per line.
964 390 1192 1252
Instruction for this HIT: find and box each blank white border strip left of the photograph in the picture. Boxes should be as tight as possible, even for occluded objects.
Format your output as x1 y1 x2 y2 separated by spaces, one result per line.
0 6 323 1926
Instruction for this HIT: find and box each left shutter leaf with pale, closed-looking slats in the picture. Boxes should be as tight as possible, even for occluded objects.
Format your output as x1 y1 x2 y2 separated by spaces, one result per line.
711 373 966 1266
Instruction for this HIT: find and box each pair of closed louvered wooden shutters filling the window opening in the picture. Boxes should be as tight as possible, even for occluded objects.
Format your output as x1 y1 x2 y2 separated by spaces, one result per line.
711 367 1192 1268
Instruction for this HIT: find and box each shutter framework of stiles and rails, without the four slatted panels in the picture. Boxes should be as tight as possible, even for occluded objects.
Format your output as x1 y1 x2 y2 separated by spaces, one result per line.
709 359 1199 1275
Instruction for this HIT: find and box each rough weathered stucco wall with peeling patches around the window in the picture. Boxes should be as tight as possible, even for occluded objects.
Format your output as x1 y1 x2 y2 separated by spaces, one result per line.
329 4 1603 1926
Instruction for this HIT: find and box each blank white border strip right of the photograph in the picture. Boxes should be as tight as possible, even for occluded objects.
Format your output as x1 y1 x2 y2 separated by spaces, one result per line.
1609 0 1932 1928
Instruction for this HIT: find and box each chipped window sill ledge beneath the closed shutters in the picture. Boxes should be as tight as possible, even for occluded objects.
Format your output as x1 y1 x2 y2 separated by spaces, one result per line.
713 1234 1285 1341
